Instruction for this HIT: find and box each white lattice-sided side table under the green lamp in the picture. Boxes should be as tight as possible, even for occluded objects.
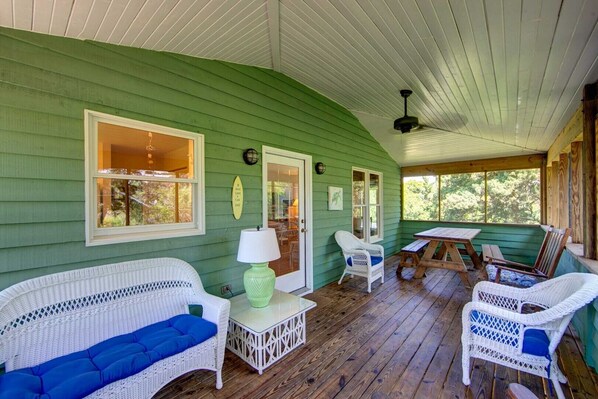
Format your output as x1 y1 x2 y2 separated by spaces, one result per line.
226 290 316 374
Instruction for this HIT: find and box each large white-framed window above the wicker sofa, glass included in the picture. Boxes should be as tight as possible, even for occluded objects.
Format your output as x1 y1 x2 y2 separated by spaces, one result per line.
85 110 205 246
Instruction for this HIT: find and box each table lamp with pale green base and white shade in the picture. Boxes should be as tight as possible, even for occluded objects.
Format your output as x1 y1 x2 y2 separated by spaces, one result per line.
237 226 280 308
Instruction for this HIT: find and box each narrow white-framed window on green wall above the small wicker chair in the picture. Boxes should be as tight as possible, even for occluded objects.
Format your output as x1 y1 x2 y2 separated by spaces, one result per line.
352 168 384 242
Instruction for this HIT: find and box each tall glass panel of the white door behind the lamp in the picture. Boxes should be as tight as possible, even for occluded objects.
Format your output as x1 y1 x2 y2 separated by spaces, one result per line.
266 163 301 277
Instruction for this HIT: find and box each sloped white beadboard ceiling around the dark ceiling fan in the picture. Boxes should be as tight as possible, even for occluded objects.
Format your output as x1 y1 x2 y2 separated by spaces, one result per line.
0 0 598 166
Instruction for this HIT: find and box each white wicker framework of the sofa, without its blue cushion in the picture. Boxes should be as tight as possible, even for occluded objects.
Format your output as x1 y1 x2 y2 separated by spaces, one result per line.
0 258 230 398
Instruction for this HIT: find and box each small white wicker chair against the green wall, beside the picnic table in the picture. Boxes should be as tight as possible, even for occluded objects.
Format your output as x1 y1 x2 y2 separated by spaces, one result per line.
334 231 384 292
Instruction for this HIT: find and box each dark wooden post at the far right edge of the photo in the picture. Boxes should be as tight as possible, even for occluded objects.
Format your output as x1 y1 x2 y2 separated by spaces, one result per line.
583 83 597 259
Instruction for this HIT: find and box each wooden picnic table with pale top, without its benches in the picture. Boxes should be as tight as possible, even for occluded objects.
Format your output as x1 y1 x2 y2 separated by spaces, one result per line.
414 227 483 287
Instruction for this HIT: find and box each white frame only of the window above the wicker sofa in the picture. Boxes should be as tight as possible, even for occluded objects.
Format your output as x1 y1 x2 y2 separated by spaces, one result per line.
84 109 205 246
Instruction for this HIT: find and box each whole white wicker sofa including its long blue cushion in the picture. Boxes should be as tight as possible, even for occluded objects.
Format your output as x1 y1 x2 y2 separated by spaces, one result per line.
0 258 230 398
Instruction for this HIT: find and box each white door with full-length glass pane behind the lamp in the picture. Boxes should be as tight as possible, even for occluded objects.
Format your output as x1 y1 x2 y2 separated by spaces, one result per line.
266 155 305 292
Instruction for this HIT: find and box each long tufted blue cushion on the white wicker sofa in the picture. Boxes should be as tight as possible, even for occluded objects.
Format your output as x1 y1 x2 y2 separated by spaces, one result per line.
0 314 217 399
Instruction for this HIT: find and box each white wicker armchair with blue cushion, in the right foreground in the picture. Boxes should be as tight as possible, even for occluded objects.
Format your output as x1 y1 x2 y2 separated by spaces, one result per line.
461 273 598 398
